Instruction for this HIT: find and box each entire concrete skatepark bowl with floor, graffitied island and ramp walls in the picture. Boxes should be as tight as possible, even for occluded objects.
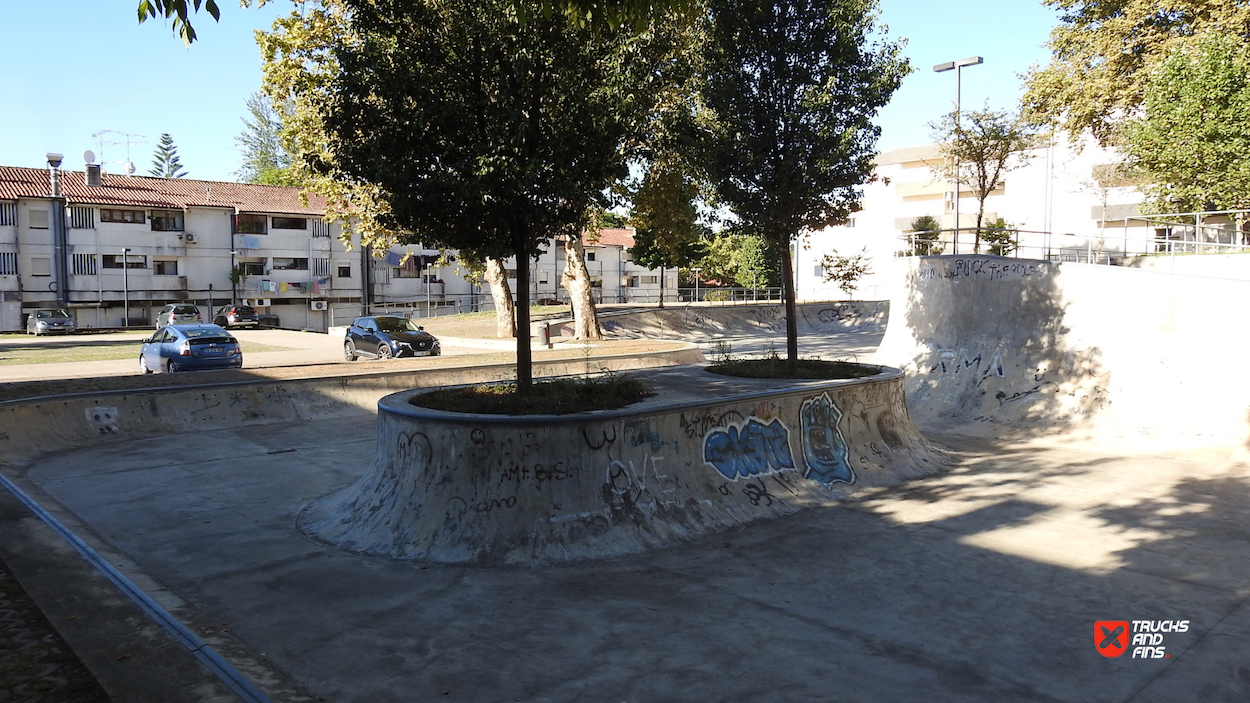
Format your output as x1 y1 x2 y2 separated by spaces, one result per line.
0 262 1250 702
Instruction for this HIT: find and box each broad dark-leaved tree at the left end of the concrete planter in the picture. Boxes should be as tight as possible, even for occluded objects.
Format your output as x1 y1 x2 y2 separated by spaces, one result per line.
261 0 680 393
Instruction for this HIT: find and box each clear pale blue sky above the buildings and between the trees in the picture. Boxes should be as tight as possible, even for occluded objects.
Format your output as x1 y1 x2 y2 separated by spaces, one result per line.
0 0 1056 180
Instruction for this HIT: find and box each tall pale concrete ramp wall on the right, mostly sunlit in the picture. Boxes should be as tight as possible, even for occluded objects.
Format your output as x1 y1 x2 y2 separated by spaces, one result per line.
874 256 1250 443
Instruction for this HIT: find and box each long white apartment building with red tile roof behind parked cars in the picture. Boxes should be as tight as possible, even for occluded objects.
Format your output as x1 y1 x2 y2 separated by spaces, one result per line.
0 165 676 331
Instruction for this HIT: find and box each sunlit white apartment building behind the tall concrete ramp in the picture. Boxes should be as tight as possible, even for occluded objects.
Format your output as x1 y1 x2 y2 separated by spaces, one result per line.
795 136 1160 300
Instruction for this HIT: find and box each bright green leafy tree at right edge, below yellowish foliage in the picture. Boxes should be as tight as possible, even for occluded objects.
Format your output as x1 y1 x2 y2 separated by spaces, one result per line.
1121 33 1250 213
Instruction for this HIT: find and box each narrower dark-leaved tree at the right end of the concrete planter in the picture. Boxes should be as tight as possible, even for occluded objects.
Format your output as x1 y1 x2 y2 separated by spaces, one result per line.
704 0 910 368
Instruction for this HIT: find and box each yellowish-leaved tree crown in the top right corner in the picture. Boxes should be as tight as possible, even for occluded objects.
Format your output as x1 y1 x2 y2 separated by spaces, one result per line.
1023 0 1250 146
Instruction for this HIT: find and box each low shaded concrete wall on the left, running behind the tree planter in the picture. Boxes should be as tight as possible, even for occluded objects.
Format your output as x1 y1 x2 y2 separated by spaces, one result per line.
0 345 703 468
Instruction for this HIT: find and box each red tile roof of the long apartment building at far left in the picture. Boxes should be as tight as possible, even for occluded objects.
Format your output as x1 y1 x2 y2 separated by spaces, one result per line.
0 166 325 215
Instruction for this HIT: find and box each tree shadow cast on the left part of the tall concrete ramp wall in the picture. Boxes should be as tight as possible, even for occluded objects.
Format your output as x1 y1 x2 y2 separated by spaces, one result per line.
895 256 1110 437
